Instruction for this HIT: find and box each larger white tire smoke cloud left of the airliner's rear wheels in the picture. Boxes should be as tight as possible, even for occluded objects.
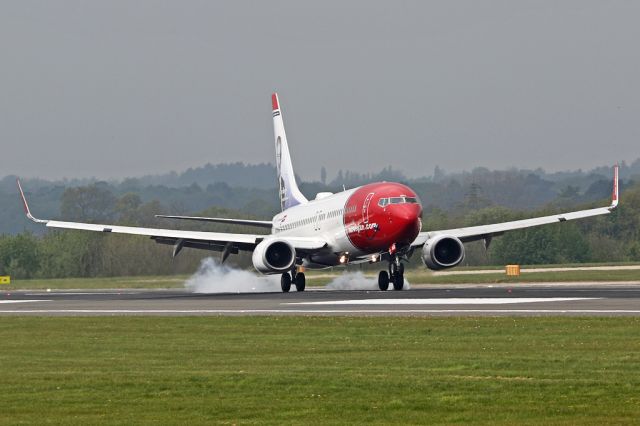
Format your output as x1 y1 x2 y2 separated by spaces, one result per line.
184 257 284 293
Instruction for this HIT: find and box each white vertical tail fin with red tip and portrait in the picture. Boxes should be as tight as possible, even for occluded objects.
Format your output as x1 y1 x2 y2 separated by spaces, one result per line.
271 93 308 210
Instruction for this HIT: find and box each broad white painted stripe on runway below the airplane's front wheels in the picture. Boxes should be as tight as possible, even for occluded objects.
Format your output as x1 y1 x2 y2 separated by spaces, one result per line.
284 297 599 305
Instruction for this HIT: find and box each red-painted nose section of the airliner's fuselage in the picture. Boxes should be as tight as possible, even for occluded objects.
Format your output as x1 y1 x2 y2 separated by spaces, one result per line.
343 182 422 253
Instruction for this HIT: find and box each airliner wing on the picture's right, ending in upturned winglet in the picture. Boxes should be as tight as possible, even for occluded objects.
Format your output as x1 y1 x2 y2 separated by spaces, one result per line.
411 165 619 246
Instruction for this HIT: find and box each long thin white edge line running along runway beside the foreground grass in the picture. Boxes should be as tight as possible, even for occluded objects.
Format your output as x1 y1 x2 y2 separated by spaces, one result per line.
0 309 640 314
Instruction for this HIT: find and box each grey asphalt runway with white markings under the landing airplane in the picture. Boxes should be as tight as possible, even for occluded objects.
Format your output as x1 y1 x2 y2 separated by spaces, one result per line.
0 283 640 316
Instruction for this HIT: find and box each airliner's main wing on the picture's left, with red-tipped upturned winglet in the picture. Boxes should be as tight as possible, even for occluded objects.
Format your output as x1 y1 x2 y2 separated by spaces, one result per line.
17 181 326 256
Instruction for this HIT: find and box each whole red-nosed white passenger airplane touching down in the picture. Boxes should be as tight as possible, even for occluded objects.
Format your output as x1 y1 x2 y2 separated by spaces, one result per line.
17 93 619 293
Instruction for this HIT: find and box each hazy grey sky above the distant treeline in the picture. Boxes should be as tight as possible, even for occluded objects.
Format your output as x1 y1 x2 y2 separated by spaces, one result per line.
0 0 640 179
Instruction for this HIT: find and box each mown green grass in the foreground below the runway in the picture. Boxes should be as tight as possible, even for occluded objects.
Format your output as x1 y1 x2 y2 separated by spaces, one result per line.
0 317 640 425
